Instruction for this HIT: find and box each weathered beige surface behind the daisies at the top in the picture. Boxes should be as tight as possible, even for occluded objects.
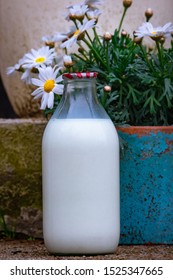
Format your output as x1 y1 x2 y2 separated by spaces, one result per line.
0 0 173 117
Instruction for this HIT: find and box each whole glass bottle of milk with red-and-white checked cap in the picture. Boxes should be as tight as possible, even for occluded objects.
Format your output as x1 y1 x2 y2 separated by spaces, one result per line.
42 73 120 254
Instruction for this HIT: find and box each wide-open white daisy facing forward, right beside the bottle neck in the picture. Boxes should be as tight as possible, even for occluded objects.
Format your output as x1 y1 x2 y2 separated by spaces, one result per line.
31 66 64 110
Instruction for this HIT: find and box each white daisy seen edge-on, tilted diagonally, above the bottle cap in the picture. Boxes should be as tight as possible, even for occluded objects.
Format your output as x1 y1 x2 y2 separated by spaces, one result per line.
60 19 95 49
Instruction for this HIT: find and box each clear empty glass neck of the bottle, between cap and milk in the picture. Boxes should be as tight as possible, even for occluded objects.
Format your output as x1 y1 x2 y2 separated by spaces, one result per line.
54 78 109 119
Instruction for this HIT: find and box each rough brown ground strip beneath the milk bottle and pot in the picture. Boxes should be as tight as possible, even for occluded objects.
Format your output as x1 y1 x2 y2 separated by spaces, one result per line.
0 239 173 260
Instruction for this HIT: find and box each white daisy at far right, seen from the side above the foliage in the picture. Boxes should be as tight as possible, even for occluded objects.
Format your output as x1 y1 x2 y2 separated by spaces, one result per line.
134 22 173 39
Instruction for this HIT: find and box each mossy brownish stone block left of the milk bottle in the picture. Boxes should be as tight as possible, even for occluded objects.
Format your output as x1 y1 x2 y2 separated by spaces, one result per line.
0 119 46 237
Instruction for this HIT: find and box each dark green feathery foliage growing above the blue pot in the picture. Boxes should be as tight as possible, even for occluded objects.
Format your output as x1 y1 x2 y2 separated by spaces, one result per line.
70 30 173 125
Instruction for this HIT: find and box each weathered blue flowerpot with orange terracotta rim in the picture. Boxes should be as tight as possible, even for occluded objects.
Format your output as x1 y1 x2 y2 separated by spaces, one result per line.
118 126 173 244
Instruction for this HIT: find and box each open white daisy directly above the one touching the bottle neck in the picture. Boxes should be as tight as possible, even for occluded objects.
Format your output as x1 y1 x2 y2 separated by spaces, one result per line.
22 46 56 69
